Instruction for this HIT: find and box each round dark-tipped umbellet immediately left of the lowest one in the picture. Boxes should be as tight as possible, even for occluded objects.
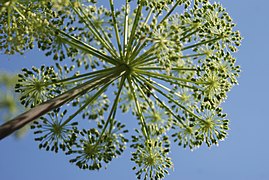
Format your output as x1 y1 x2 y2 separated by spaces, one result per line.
66 121 128 170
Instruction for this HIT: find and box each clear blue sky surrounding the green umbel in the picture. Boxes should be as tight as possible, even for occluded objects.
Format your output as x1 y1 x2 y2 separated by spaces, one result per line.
0 0 269 180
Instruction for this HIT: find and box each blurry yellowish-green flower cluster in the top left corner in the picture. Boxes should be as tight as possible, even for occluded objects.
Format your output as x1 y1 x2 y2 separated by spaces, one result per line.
0 1 48 54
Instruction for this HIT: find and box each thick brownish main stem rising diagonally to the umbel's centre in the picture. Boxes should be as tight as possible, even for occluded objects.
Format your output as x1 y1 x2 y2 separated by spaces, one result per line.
0 66 123 140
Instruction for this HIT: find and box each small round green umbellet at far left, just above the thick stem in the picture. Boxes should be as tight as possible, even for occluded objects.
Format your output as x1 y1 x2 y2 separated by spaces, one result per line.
15 63 82 107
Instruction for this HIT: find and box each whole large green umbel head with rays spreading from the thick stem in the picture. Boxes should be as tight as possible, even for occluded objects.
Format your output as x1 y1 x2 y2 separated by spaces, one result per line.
0 0 242 179
